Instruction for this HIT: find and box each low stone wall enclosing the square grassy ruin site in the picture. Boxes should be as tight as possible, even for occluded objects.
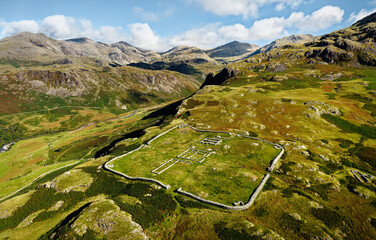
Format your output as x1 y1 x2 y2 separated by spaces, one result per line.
103 124 285 211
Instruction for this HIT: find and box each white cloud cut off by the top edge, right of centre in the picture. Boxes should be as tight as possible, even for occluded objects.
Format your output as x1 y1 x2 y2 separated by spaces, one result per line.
194 0 303 18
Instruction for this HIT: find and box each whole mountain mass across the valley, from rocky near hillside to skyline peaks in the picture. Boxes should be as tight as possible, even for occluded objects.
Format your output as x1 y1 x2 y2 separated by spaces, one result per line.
0 32 316 113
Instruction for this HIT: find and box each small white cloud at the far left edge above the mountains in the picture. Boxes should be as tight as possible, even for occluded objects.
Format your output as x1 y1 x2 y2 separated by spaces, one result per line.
0 20 39 37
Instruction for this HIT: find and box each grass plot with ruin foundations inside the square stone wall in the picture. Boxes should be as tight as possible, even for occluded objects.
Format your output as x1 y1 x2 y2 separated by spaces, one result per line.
113 127 279 205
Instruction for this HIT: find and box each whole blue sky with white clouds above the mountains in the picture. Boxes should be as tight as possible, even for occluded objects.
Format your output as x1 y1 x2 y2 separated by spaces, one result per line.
0 0 376 51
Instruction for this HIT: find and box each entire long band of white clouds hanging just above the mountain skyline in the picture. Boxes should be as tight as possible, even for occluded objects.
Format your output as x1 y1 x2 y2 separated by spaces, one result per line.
0 5 344 51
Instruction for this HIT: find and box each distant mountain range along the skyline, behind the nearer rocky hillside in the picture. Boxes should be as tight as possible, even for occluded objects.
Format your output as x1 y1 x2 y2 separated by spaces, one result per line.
0 32 313 66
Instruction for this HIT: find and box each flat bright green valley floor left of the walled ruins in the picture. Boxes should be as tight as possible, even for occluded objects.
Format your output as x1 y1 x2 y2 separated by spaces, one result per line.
0 108 153 198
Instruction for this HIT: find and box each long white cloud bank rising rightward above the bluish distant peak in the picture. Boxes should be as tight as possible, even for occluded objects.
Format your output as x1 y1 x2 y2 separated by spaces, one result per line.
166 6 344 49
